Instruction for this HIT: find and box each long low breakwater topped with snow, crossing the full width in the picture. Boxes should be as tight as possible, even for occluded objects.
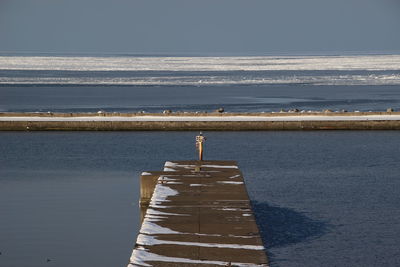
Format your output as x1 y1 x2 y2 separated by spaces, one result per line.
0 112 400 131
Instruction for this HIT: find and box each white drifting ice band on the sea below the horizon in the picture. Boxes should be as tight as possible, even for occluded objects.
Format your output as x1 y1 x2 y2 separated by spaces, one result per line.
0 55 400 86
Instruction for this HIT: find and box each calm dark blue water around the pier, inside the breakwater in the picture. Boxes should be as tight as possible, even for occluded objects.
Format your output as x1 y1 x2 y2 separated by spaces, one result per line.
0 131 400 267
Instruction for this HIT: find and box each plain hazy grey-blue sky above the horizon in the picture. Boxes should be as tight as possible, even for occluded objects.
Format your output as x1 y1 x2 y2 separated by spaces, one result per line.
0 0 400 54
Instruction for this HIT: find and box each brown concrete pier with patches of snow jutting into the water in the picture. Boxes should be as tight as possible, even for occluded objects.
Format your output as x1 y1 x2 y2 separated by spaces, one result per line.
128 161 268 267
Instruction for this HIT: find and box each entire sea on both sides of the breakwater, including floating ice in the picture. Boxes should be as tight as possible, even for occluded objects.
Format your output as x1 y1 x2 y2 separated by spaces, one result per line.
0 53 400 267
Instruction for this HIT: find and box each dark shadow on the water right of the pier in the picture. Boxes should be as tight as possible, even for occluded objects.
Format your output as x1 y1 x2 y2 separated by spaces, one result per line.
252 202 330 249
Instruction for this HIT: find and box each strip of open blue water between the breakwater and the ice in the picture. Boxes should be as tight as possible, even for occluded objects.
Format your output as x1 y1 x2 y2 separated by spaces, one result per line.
0 84 400 112
